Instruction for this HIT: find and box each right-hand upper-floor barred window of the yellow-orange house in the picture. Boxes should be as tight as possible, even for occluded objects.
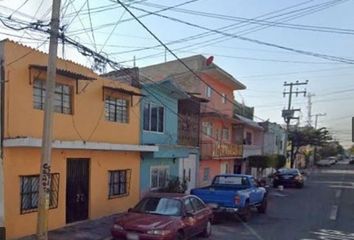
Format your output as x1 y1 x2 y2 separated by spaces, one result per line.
105 96 129 123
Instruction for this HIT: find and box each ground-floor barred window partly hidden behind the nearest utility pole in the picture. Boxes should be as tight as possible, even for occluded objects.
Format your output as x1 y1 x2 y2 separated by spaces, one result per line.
20 173 59 214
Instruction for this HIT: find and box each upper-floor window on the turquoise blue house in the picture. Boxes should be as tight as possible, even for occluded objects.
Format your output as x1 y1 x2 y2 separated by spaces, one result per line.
143 103 165 132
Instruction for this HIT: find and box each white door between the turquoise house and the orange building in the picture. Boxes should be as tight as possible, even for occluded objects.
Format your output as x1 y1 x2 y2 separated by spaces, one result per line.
179 154 197 193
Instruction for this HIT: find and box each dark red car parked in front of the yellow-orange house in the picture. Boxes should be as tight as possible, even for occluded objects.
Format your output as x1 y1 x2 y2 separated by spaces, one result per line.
111 193 213 240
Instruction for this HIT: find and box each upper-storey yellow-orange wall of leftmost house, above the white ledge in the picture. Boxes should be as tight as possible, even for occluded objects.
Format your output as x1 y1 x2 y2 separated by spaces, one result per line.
2 41 140 144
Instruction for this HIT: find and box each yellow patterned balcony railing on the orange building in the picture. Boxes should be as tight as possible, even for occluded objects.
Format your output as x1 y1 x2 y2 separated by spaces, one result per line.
201 143 242 159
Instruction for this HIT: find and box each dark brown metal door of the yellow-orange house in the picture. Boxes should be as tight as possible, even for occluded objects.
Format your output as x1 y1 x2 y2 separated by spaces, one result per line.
66 158 89 223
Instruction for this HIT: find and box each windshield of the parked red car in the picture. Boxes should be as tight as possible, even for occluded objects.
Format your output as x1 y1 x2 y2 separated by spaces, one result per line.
133 197 182 216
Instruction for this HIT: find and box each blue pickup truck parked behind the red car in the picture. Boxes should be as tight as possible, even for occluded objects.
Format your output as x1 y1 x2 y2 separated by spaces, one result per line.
191 174 267 222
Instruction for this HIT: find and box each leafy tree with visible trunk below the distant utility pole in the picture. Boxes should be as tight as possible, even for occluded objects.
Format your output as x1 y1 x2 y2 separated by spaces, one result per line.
288 126 332 167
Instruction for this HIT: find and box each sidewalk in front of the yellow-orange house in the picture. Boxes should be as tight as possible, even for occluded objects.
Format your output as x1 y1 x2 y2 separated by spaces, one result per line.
19 214 119 240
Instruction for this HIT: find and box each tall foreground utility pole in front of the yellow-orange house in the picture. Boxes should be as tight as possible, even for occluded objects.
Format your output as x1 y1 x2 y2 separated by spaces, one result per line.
37 0 61 240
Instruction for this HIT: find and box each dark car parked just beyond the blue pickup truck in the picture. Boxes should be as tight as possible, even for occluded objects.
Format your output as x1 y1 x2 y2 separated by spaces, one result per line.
273 168 305 188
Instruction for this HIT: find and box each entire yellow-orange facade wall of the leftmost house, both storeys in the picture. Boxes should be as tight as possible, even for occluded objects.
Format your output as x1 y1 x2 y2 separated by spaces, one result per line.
0 40 144 238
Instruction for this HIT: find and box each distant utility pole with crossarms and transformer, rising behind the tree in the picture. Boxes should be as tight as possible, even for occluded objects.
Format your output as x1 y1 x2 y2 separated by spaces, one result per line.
282 80 309 167
